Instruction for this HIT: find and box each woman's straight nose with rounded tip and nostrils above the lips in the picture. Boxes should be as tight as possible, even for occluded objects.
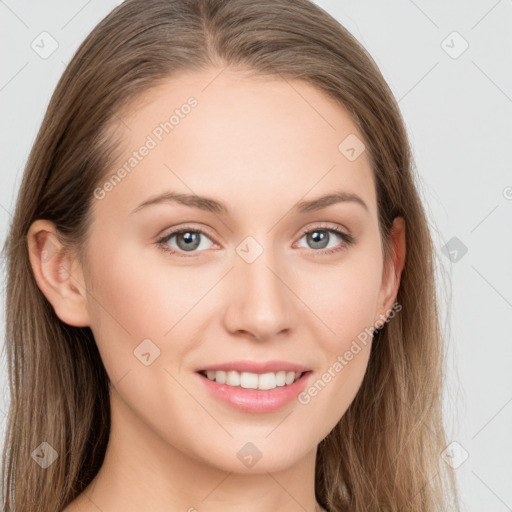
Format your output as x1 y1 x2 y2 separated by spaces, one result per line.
224 247 296 341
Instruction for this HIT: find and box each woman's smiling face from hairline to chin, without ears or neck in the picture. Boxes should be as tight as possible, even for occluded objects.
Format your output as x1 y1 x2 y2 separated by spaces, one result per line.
72 69 402 472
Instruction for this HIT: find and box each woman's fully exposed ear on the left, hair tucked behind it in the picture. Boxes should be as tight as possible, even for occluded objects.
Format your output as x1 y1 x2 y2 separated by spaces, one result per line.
27 219 90 327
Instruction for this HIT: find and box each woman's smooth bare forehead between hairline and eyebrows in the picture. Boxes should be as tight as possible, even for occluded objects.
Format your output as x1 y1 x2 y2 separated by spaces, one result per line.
96 69 375 218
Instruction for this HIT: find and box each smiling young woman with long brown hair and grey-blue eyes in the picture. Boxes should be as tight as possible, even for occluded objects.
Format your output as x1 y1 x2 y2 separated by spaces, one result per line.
4 0 456 512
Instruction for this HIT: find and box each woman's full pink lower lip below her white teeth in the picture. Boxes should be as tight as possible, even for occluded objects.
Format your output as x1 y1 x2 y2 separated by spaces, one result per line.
197 371 311 413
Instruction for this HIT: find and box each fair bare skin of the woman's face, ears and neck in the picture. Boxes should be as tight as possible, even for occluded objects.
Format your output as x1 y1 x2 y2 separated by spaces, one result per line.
28 69 405 512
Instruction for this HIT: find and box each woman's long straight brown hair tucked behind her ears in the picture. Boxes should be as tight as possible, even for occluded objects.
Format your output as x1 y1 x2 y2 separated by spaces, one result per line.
2 0 458 512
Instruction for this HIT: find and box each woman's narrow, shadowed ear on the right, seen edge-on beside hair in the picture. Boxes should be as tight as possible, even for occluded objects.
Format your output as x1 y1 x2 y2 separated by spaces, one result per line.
374 217 406 327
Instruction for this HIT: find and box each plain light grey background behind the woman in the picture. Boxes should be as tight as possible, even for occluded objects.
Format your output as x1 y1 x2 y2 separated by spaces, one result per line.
0 0 512 512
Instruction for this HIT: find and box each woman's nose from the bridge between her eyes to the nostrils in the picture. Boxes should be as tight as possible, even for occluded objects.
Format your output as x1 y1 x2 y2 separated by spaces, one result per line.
226 237 293 339
